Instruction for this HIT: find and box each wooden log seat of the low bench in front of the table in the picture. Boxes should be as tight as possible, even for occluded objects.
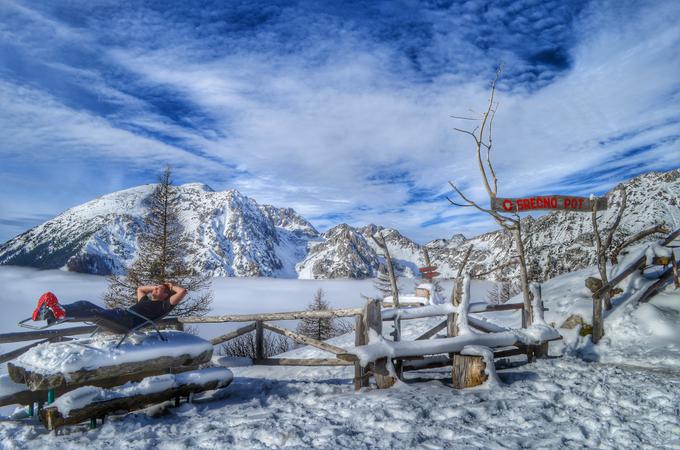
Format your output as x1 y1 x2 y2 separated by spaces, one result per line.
40 380 220 430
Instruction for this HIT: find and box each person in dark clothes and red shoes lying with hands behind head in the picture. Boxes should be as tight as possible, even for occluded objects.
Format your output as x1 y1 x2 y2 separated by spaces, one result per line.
32 283 187 331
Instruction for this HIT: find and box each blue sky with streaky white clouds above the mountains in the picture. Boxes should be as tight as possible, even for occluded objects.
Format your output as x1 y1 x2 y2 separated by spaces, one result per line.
0 0 680 242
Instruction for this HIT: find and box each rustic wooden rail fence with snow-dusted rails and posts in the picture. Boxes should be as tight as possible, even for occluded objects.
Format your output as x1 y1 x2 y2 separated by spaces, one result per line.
0 279 540 389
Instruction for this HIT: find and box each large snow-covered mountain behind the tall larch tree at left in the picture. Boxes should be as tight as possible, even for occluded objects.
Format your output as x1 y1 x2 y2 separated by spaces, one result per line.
0 183 318 276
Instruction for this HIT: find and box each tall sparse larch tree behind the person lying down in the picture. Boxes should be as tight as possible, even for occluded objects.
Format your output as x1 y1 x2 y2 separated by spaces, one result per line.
104 167 212 316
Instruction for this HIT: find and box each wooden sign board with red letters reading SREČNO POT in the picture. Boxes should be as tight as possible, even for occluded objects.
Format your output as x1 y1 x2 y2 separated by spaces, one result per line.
491 195 607 212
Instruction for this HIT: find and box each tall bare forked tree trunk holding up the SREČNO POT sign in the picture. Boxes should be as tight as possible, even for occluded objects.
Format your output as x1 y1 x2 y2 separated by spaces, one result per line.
447 67 533 325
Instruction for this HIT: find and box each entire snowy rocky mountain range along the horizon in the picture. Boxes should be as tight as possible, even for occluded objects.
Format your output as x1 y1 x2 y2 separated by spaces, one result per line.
0 169 680 279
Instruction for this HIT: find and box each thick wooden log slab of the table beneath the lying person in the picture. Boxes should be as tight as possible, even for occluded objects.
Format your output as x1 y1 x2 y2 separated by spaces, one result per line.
7 349 212 391
